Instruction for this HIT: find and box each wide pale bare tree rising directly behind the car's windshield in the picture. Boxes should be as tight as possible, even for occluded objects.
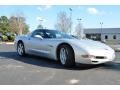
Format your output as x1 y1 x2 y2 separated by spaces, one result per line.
55 12 72 33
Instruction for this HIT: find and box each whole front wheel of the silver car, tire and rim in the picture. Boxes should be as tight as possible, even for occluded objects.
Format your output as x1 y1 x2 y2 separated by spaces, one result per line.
58 45 75 67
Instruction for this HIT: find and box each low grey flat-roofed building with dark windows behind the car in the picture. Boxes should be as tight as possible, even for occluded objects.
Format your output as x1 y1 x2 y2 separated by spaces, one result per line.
84 28 120 41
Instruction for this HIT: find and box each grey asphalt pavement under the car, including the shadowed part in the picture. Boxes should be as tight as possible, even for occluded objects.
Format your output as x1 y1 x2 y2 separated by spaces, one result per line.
0 44 120 85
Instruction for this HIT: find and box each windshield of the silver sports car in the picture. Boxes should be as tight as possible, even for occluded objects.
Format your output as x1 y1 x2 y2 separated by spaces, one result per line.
45 30 74 39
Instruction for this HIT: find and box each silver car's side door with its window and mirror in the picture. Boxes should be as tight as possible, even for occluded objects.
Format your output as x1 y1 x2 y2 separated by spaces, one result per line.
28 30 49 57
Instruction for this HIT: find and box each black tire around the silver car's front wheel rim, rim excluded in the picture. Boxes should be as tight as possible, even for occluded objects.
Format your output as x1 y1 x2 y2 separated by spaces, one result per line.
57 45 75 67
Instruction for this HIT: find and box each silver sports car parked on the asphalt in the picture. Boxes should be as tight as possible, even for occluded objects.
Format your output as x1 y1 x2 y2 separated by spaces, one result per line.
15 29 115 67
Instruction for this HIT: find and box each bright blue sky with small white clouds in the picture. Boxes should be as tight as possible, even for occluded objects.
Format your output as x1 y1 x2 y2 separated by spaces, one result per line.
0 5 120 31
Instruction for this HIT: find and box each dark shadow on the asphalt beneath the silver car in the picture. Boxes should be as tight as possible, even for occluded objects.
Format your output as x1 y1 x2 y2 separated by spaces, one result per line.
0 52 120 71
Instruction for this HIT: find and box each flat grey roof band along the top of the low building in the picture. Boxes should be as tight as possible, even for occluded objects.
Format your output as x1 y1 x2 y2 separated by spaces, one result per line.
84 28 120 34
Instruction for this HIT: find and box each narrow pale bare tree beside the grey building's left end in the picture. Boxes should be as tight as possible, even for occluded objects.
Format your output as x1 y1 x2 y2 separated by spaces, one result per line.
75 19 84 38
